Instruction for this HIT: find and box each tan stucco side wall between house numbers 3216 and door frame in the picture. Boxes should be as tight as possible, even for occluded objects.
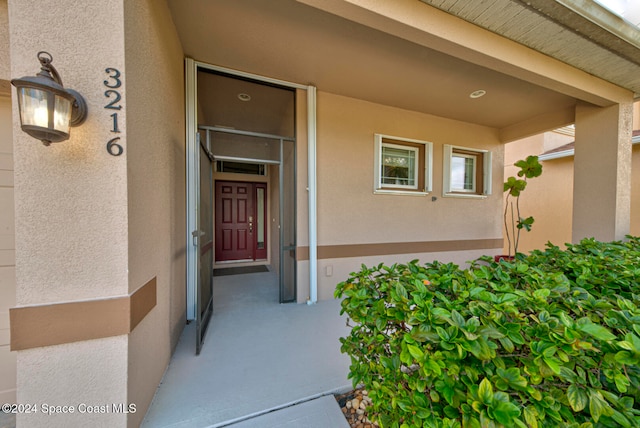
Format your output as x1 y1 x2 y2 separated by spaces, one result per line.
124 0 185 426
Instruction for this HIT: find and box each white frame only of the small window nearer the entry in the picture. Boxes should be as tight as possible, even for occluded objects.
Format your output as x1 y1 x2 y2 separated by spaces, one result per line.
373 134 433 196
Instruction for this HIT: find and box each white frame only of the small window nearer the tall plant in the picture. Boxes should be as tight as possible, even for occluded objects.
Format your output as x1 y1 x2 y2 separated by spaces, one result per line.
442 144 492 199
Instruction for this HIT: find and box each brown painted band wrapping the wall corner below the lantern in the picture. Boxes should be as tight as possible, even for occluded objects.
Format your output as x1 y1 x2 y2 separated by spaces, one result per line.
9 277 157 351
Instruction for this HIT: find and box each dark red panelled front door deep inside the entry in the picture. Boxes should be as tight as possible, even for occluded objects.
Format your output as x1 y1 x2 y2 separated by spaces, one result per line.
215 181 266 261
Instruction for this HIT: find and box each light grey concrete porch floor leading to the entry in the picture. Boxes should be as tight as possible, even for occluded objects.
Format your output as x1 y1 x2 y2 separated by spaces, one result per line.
142 272 351 428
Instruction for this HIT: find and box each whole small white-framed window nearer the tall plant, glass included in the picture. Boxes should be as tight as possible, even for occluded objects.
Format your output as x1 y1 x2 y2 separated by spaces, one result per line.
443 144 491 197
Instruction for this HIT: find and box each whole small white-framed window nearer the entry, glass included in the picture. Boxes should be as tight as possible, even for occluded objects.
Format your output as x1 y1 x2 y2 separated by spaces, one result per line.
374 134 432 195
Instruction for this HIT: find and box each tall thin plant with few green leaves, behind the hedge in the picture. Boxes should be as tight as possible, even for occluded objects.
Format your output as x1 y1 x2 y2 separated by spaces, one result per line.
504 156 542 256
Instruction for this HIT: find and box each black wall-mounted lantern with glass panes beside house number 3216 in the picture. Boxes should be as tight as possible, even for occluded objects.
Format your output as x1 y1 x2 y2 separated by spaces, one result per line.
11 52 87 146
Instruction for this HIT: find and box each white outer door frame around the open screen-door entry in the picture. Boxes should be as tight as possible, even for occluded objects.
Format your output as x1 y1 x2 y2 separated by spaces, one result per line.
185 58 318 320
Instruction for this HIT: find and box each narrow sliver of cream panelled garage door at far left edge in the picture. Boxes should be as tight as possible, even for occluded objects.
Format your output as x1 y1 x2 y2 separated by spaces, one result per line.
0 91 16 403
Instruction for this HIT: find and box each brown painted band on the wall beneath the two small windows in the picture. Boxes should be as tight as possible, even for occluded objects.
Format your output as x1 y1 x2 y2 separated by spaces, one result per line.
296 238 504 260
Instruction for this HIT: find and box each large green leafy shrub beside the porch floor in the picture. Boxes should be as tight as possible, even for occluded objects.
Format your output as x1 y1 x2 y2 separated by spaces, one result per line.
335 238 640 428
